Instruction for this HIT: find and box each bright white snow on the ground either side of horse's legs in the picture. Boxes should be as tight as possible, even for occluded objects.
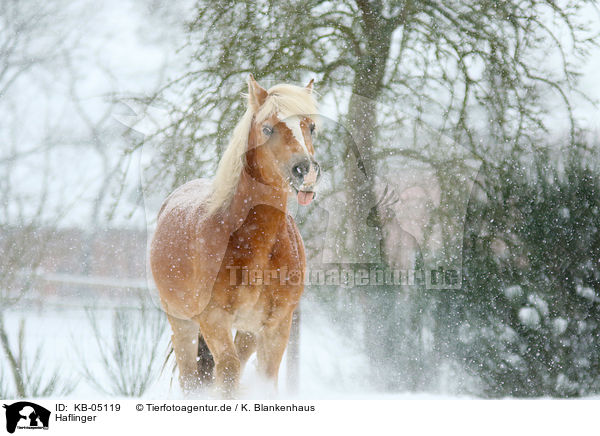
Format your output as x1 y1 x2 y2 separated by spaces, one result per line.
2 299 452 399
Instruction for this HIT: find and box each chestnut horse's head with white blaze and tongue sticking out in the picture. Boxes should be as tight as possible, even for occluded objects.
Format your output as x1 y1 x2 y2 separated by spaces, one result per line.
247 76 321 206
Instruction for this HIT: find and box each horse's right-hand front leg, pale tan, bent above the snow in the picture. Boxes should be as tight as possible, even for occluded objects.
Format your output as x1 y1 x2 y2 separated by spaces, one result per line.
257 308 293 389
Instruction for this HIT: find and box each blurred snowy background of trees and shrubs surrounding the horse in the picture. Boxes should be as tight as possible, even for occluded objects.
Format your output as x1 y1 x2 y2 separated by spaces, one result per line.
0 0 600 398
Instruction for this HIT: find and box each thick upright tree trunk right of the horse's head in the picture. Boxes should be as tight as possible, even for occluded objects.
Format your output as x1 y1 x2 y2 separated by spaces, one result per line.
345 1 398 390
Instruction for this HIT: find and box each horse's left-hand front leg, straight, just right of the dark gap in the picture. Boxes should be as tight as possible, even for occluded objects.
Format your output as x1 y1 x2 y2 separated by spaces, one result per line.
194 306 240 397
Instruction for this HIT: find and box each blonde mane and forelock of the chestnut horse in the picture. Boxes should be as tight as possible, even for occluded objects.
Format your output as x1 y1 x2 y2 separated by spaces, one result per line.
207 84 317 215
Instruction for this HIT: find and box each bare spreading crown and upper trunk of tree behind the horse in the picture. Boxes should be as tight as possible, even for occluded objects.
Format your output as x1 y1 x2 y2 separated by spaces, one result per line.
129 0 595 257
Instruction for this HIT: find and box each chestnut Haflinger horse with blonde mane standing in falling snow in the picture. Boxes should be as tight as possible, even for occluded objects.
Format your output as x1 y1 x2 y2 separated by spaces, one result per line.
150 76 320 397
